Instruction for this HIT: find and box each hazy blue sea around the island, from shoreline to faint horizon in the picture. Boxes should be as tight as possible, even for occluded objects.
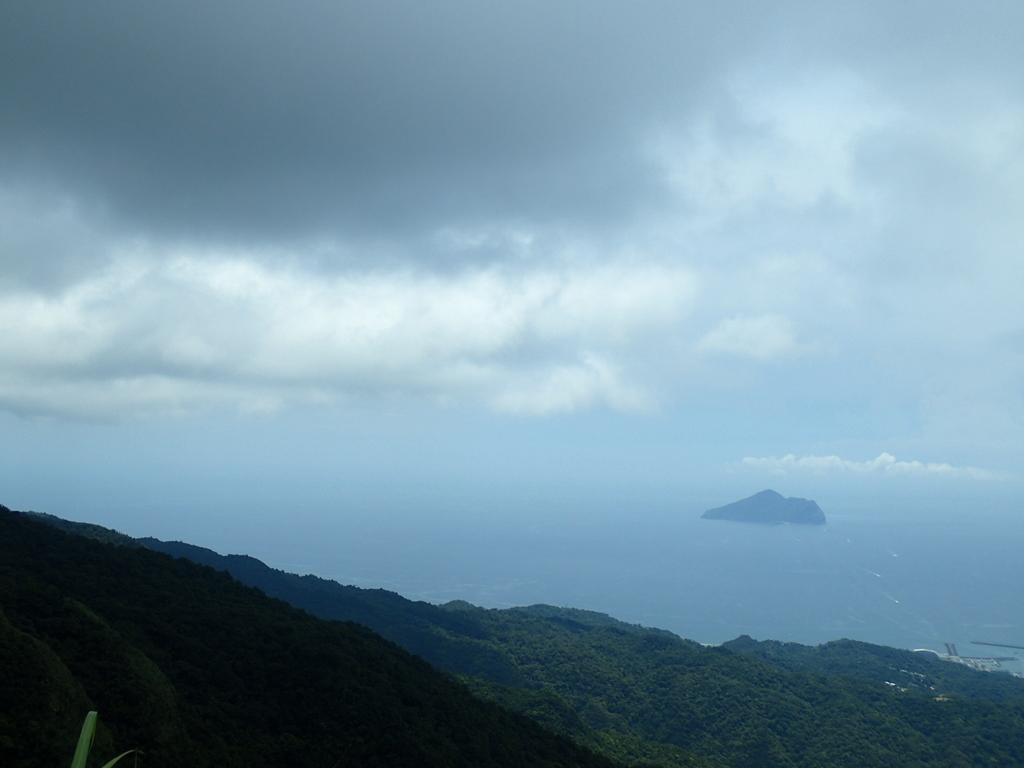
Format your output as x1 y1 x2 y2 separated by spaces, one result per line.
8 444 1024 656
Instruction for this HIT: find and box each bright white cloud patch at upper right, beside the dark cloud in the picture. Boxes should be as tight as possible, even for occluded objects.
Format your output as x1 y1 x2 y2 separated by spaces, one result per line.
649 68 899 225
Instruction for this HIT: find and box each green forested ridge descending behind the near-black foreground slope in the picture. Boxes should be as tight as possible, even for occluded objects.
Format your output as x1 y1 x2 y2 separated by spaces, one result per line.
22 507 1024 768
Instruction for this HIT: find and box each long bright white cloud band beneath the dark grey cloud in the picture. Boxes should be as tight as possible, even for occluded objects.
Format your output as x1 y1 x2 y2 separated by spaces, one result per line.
0 254 696 418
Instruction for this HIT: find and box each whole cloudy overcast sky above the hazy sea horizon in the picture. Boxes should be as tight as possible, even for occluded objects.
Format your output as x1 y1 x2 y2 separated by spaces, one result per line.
0 0 1024 534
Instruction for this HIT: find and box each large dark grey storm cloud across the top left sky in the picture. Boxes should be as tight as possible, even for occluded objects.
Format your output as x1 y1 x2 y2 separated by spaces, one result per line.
0 1 760 240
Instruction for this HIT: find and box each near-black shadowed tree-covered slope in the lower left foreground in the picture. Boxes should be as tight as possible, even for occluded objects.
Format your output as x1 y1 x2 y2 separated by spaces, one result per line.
0 508 610 768
